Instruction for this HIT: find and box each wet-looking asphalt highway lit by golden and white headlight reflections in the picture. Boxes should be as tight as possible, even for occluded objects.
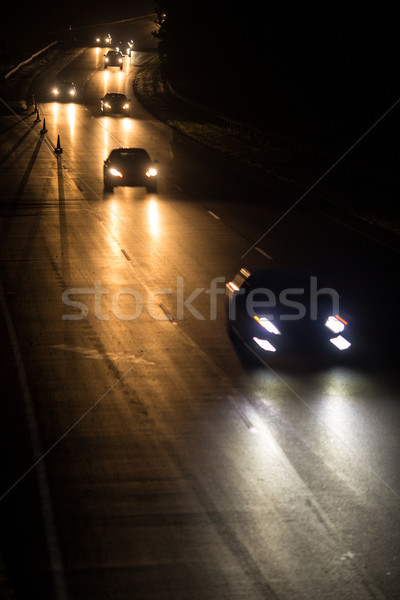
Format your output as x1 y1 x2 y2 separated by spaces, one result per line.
0 5 400 600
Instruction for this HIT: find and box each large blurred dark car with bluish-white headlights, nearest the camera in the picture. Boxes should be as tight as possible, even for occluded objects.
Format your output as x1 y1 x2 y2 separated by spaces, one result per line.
226 268 354 360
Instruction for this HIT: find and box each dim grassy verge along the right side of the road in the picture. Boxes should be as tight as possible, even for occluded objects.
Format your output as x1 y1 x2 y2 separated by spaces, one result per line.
134 56 400 246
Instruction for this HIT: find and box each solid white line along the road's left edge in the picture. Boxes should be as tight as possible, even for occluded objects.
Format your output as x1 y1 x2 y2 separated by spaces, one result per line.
0 281 68 600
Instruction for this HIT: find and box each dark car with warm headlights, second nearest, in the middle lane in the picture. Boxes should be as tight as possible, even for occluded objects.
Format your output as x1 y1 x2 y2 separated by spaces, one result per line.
104 148 157 193
